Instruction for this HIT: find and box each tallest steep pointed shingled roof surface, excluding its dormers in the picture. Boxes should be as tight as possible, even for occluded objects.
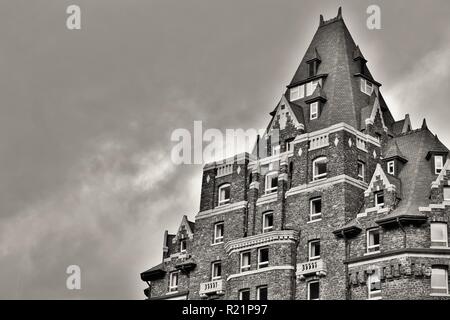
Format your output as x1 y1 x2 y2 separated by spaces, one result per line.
286 9 394 132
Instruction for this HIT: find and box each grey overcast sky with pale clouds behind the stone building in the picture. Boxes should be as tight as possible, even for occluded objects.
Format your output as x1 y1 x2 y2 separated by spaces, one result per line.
0 0 450 299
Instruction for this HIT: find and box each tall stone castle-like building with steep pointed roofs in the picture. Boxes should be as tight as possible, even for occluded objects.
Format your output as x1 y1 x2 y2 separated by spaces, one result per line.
141 9 450 300
